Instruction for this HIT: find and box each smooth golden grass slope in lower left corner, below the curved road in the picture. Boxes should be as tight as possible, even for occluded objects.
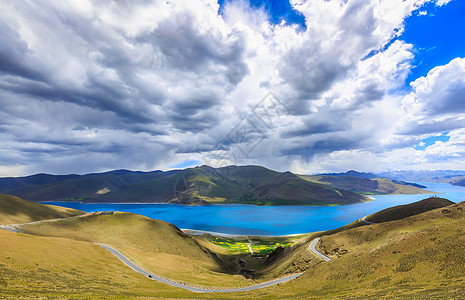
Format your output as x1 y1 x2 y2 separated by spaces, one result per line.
0 230 227 299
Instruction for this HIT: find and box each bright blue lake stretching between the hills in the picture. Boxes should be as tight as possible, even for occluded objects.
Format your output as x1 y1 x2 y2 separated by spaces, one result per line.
42 183 465 235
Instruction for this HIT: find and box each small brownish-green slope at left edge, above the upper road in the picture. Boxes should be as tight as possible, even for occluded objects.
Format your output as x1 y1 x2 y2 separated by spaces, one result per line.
0 194 84 224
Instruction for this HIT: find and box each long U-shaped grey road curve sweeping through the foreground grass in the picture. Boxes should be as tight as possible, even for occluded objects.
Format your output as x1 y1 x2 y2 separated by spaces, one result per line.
97 244 303 293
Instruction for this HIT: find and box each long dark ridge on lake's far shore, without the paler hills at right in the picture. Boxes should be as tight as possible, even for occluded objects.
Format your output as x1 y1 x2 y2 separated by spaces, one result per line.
2 166 368 205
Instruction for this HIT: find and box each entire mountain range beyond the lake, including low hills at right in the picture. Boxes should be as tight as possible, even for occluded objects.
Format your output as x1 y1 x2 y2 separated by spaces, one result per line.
0 166 430 205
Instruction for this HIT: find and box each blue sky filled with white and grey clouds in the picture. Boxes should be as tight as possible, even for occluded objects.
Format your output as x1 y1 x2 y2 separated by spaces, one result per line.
0 0 465 176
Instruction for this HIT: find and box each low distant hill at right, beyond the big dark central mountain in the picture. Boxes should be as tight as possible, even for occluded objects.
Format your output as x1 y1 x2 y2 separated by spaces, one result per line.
300 175 431 195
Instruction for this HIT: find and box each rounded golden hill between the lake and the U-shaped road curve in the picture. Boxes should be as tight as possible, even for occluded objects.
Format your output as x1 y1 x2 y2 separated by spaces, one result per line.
21 213 250 286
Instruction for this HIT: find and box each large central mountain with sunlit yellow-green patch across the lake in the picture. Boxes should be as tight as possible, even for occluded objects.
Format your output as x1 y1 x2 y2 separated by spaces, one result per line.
92 166 369 205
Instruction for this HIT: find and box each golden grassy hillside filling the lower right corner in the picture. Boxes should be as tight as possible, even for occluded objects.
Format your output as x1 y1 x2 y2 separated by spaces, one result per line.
243 202 465 299
